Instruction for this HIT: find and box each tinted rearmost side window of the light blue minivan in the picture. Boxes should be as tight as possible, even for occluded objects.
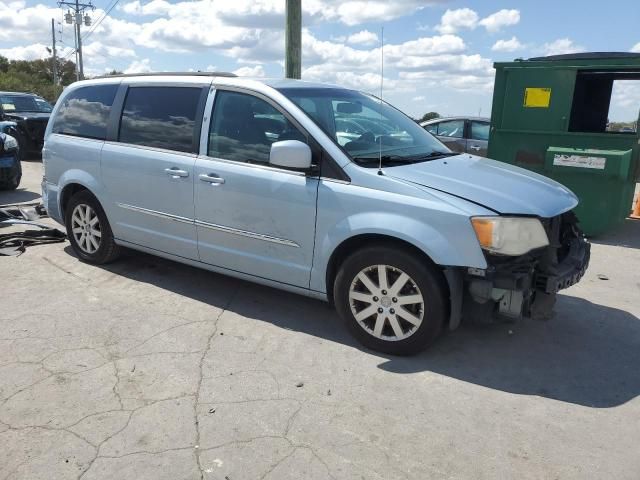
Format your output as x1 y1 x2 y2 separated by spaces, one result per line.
53 84 118 140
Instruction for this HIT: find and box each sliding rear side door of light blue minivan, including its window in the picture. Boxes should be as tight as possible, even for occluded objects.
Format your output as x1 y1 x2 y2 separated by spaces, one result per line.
101 83 208 259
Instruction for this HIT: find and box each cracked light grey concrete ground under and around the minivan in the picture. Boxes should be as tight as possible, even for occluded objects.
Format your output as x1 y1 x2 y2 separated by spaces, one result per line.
0 162 640 480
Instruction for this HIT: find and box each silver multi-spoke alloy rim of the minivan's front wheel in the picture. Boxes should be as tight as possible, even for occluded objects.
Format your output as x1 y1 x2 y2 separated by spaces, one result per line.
349 265 424 341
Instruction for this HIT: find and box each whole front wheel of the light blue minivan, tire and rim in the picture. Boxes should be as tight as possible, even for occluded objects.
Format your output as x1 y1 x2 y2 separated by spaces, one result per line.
334 245 447 355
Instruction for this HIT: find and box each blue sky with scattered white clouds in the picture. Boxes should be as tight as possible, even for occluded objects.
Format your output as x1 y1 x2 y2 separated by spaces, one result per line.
0 0 640 120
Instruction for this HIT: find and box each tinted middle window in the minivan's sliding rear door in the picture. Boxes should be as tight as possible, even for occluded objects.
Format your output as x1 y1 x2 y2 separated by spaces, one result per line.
119 87 202 152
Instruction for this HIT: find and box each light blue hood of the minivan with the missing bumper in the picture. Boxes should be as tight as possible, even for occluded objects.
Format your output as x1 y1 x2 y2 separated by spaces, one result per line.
385 154 578 218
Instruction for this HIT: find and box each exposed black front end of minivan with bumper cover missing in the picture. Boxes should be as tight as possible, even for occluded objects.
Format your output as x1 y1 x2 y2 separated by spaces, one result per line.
450 212 591 323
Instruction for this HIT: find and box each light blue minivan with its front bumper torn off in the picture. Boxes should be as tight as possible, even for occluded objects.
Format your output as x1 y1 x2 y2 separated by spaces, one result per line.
42 73 590 354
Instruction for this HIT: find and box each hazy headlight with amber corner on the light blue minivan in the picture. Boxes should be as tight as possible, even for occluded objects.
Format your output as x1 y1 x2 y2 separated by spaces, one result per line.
471 217 549 255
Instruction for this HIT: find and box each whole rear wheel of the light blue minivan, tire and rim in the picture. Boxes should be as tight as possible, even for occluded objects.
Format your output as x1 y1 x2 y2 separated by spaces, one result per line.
65 190 120 265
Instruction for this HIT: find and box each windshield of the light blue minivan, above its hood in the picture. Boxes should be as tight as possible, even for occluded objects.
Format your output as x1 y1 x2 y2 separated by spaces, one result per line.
279 88 452 167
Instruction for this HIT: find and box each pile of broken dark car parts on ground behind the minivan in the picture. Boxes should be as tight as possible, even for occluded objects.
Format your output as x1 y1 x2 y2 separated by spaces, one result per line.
0 205 67 256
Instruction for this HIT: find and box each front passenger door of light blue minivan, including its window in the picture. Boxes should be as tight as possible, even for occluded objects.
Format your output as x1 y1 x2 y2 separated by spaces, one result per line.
195 90 318 288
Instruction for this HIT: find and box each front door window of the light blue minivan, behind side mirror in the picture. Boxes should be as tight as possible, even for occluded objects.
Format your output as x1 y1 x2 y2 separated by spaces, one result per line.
208 91 306 163
